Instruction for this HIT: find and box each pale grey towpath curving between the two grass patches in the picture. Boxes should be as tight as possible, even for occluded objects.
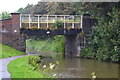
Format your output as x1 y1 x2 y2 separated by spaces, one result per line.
0 55 26 80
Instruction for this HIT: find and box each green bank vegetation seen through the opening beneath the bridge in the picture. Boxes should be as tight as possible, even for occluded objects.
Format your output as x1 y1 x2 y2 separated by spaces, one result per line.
26 35 64 57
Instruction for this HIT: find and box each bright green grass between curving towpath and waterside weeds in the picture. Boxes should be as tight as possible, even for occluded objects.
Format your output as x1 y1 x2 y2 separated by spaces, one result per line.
8 55 47 78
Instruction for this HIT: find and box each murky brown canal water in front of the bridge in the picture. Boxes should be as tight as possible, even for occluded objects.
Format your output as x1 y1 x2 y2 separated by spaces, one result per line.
39 58 118 78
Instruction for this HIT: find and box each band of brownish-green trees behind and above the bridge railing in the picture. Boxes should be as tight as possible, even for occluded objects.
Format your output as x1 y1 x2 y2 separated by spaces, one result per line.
18 1 119 19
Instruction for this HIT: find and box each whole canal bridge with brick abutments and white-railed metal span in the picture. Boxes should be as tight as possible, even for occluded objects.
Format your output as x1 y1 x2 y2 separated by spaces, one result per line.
0 13 97 56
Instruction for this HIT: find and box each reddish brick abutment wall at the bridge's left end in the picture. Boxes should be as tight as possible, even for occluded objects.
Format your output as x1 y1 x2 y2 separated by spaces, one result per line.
0 13 26 52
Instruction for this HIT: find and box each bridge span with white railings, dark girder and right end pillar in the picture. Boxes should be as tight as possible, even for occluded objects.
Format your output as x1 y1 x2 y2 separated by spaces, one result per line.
20 14 95 35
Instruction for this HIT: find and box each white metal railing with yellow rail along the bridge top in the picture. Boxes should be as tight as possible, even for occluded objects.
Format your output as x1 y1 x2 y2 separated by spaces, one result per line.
20 14 82 29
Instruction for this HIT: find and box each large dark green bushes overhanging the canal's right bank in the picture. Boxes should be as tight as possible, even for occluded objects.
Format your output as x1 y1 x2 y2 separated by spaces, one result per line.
81 7 120 62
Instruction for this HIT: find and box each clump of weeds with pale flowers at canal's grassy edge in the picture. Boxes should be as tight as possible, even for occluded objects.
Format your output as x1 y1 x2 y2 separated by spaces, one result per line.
28 55 60 78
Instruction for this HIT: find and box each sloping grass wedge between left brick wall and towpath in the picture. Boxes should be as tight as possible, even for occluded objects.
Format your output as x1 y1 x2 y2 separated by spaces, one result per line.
0 43 25 59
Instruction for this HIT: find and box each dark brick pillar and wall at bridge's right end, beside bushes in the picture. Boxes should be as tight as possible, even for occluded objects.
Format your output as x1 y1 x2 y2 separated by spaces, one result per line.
76 14 98 53
